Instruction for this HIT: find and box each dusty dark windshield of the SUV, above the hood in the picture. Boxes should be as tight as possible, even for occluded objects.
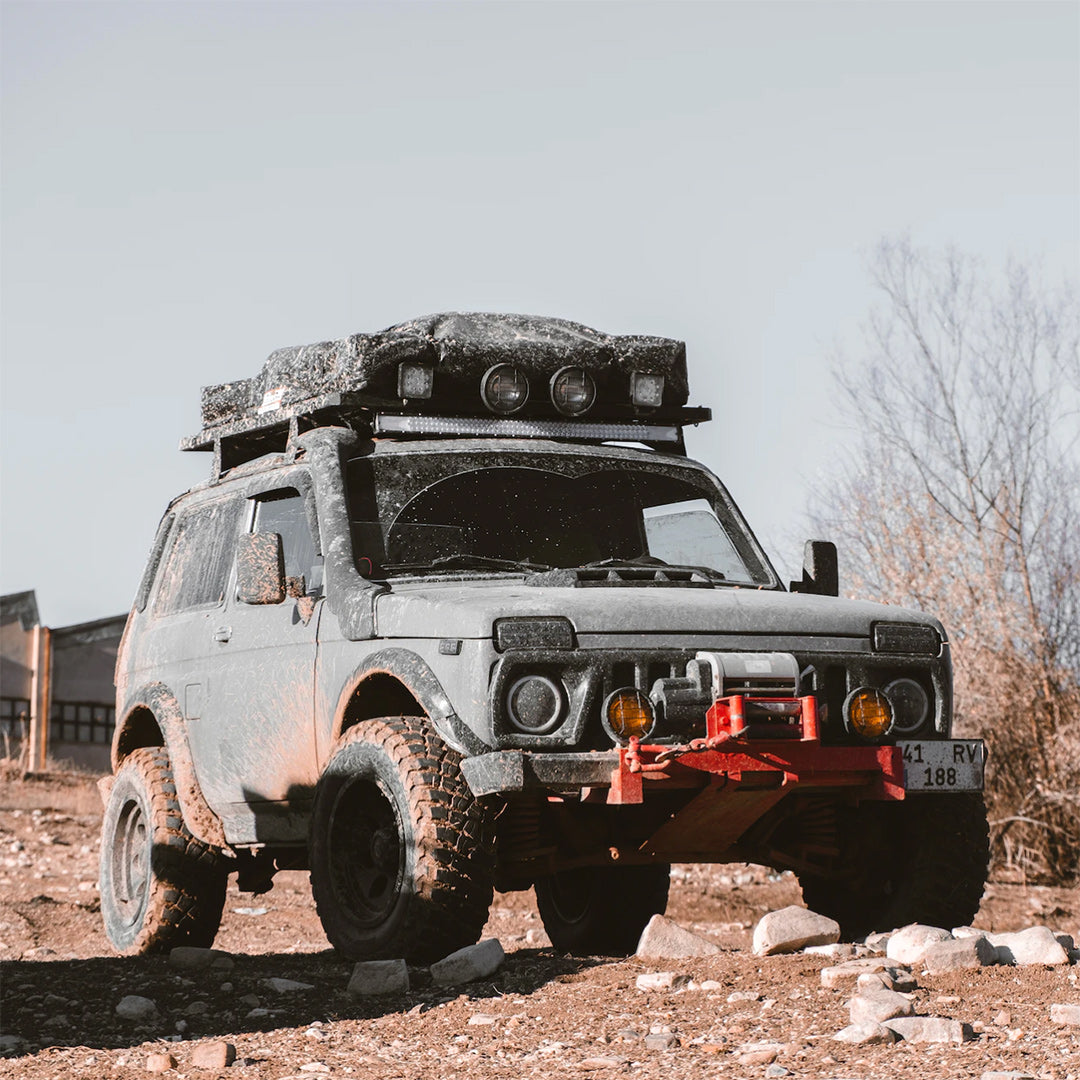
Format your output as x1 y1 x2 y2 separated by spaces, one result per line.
349 450 774 585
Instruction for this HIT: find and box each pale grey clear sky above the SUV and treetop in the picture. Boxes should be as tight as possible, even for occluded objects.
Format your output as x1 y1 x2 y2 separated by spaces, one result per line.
0 0 1080 625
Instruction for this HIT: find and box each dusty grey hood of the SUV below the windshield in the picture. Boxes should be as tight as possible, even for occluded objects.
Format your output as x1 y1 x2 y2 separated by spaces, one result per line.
376 579 944 645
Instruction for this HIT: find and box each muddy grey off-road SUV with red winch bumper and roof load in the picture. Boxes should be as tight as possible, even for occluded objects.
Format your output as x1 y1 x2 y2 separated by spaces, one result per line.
100 314 987 962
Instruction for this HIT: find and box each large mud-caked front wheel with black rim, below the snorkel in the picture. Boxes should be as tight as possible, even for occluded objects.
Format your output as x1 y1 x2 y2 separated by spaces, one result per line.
310 716 494 963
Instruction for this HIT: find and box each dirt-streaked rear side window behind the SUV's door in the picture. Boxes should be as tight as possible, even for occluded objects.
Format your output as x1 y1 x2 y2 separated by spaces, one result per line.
154 499 240 615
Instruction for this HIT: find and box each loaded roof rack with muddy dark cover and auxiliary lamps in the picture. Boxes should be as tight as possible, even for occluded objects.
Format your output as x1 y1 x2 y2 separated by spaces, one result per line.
180 312 712 473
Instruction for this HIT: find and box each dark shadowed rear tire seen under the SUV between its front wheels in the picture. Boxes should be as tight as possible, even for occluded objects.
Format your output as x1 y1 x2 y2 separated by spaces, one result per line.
536 863 671 956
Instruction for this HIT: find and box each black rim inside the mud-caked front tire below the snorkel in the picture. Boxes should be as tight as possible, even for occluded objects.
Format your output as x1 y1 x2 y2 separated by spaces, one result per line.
329 780 405 928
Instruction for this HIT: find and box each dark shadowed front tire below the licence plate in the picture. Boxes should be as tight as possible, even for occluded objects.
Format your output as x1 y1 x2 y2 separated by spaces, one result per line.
799 794 990 941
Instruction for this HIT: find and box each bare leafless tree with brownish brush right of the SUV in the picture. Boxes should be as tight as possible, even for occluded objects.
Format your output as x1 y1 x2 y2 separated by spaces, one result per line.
814 241 1080 879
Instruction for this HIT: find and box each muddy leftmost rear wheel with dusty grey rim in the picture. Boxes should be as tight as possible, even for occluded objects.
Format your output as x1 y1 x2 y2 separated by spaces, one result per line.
100 746 228 954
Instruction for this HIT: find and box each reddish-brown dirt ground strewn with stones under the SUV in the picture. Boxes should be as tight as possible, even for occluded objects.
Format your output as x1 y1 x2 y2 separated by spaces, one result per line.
0 780 1080 1080
